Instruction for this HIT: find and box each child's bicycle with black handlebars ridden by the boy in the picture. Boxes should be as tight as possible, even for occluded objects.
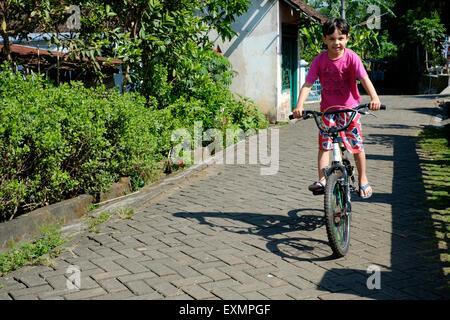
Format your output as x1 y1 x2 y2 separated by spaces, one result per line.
289 104 386 258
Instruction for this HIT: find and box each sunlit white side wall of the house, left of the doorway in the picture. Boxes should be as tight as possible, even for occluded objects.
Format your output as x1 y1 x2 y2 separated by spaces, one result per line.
210 0 281 122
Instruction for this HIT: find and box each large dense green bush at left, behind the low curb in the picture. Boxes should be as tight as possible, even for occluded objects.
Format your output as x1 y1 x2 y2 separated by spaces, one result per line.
0 71 161 219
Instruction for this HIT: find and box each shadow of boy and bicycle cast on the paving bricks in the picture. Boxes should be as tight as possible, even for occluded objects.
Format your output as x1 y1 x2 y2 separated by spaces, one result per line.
173 208 334 261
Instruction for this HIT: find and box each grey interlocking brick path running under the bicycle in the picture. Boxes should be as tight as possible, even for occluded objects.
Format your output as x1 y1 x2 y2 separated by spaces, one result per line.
0 96 450 299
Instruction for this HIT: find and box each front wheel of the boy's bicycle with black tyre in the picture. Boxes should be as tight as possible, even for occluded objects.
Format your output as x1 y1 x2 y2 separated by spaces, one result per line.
325 172 350 257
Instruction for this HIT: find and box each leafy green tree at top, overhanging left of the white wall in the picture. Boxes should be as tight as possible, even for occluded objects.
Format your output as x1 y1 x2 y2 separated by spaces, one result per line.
60 0 253 105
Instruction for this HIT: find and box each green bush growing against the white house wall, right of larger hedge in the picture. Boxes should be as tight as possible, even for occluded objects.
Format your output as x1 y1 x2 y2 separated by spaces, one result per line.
168 48 268 131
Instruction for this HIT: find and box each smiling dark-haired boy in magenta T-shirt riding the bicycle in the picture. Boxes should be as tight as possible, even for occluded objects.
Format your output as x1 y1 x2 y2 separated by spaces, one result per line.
293 18 381 199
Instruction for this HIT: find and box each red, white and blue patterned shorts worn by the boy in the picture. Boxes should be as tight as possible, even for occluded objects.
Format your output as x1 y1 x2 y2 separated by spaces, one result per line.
319 113 364 153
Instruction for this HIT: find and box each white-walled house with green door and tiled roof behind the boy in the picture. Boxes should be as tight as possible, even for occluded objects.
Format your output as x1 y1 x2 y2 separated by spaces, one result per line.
210 0 326 123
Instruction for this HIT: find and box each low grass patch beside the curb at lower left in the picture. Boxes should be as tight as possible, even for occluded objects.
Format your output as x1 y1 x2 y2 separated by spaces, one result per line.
0 224 67 276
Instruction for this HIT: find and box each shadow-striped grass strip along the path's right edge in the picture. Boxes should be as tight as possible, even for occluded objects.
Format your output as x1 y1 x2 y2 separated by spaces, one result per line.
419 127 450 270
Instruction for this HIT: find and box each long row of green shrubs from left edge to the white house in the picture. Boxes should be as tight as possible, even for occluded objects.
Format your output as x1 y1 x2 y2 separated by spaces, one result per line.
0 63 267 220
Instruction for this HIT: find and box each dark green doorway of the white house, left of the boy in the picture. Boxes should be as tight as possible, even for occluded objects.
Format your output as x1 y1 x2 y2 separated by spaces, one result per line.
281 25 298 110
